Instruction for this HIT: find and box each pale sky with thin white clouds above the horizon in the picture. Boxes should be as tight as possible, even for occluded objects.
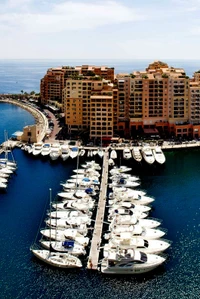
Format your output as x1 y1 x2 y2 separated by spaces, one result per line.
0 0 200 60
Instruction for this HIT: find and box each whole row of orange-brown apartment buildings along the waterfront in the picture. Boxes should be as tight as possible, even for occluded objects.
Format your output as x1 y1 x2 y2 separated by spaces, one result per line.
41 61 200 139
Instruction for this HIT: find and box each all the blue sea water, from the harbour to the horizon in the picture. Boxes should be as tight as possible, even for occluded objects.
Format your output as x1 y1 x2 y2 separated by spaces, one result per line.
0 60 200 299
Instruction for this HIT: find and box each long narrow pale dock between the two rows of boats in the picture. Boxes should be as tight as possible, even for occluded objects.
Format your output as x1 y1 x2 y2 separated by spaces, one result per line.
87 148 109 270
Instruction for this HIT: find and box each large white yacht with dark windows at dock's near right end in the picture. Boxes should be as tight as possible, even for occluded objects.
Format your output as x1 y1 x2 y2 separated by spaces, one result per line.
101 249 166 275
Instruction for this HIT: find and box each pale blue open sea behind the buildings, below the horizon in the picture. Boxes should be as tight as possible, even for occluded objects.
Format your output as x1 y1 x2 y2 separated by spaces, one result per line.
0 59 200 94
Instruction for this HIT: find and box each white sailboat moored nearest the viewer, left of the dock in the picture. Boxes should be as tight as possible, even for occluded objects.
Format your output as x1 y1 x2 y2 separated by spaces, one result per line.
31 249 82 269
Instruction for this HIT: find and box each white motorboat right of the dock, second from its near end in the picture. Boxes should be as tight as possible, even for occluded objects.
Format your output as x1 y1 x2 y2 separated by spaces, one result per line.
104 237 171 254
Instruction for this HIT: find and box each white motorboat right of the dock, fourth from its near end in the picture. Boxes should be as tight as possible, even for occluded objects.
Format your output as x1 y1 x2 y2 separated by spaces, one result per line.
109 214 161 230
